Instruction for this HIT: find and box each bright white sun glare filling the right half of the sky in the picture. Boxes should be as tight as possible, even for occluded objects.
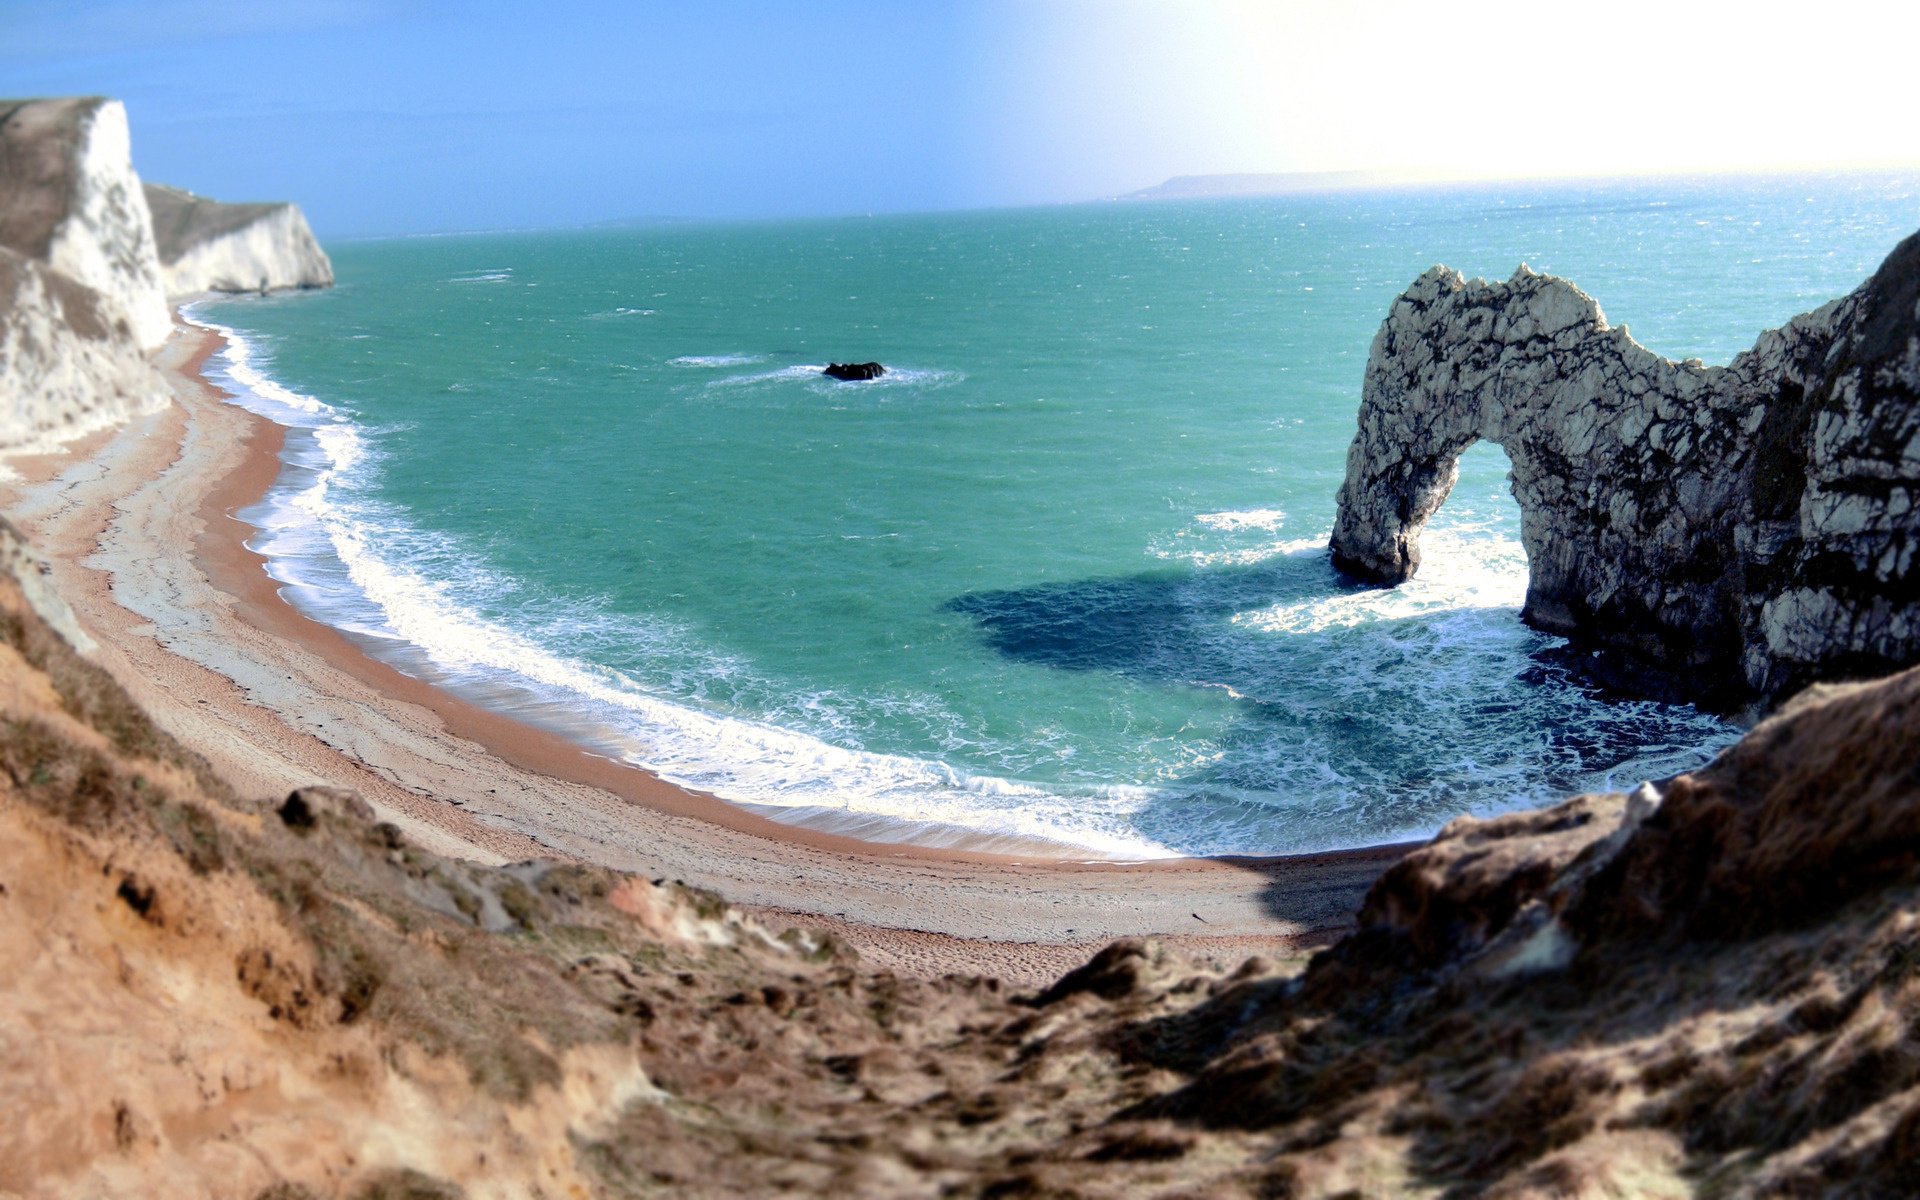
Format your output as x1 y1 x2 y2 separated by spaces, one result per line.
977 0 1920 204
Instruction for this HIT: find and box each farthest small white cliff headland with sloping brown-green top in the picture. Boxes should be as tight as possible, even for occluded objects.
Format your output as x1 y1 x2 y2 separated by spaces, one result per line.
146 184 334 296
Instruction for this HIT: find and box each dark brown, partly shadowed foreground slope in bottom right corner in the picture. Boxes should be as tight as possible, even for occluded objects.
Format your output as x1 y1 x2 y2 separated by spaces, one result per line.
1135 672 1920 1198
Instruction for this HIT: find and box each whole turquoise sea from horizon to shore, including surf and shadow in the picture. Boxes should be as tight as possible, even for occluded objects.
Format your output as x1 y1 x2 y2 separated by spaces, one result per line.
196 179 1920 856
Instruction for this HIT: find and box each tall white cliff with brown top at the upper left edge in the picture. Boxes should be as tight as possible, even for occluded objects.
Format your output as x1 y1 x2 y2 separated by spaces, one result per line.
0 96 173 349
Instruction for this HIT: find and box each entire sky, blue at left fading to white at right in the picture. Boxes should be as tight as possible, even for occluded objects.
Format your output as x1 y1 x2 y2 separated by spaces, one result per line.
0 0 1920 236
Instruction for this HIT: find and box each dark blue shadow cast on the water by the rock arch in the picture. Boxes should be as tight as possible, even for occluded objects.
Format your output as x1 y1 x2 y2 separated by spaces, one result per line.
945 553 1728 871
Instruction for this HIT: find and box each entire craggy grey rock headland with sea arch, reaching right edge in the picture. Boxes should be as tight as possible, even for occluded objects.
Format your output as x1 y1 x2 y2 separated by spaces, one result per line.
1332 234 1920 708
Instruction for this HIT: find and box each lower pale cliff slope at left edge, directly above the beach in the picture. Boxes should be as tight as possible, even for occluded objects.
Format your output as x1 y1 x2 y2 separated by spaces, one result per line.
0 248 167 457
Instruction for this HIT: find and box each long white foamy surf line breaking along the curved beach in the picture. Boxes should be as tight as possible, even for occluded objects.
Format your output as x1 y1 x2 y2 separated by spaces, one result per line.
183 312 1173 858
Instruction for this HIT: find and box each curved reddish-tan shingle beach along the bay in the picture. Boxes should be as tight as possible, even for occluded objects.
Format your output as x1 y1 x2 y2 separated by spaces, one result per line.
0 324 1402 981
